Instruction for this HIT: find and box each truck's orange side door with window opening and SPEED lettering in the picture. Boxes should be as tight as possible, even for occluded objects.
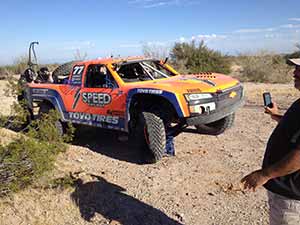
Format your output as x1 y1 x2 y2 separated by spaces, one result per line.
69 64 126 130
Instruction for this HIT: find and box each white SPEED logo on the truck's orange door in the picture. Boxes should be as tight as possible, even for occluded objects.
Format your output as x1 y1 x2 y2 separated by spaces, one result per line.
82 92 111 107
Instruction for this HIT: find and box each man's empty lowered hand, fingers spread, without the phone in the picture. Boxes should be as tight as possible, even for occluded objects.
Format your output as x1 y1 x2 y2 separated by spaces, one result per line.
241 170 270 191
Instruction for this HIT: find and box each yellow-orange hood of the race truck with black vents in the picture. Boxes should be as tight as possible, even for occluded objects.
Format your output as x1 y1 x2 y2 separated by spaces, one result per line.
127 73 239 94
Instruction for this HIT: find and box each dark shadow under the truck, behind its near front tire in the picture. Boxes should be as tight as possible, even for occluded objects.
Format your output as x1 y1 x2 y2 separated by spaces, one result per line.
71 126 145 164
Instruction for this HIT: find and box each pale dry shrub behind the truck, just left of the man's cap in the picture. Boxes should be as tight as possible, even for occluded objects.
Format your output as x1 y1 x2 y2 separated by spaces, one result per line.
234 52 292 83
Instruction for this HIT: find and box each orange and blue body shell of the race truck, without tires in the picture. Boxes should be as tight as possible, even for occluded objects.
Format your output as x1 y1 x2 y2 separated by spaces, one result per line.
28 58 243 132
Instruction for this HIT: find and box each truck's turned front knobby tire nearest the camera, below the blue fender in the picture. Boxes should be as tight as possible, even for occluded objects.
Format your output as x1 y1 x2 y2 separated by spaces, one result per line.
132 112 166 163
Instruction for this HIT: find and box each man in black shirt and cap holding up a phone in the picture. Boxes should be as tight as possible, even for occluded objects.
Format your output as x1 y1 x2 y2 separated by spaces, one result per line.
241 58 300 225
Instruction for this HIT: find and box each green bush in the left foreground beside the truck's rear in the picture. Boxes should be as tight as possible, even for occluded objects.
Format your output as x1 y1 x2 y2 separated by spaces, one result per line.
0 81 74 197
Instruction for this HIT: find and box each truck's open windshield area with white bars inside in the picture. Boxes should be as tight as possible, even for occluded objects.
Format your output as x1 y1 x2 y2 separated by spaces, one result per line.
117 60 175 82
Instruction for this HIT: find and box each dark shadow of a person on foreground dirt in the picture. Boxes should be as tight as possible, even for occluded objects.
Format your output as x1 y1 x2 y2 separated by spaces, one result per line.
71 175 181 225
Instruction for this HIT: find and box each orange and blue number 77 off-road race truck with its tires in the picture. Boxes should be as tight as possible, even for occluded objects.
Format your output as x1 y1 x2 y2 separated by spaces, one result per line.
26 57 243 162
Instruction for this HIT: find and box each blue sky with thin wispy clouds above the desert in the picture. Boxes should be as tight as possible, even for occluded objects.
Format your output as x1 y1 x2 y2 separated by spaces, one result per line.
0 0 300 64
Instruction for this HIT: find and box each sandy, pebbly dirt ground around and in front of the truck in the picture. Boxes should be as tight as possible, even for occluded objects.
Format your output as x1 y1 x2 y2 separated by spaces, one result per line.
0 82 299 225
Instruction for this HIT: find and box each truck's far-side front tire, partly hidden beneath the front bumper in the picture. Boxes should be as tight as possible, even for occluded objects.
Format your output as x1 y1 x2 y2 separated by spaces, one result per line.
195 113 235 135
